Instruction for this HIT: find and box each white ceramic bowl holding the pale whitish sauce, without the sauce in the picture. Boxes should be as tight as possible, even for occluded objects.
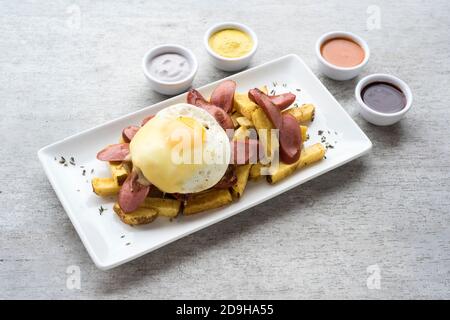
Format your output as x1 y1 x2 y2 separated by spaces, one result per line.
142 44 198 95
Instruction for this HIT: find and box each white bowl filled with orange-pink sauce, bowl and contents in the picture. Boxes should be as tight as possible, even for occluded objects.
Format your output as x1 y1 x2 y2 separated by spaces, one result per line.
316 31 370 81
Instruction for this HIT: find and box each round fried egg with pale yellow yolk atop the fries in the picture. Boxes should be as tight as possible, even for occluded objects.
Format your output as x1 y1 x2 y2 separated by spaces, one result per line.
130 103 231 194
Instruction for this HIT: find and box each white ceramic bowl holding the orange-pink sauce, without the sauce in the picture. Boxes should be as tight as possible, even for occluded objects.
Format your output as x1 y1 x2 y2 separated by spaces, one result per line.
316 31 370 81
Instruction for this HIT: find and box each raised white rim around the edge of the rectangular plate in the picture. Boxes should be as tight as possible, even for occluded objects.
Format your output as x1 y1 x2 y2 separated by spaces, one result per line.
37 53 373 270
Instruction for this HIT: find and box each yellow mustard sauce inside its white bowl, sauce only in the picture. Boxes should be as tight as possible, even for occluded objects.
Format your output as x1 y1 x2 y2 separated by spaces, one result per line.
208 29 253 58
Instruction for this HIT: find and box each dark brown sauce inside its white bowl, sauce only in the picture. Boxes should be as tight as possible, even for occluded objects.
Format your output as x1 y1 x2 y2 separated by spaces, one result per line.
361 82 406 113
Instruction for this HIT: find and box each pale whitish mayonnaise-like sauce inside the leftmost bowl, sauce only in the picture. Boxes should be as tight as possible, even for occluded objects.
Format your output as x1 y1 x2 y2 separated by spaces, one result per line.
148 53 191 82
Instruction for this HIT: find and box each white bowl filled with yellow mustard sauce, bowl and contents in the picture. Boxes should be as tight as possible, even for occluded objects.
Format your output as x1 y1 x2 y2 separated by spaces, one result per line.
204 22 258 71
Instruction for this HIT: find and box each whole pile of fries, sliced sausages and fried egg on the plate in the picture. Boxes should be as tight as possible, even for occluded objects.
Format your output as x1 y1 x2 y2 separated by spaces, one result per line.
92 80 326 225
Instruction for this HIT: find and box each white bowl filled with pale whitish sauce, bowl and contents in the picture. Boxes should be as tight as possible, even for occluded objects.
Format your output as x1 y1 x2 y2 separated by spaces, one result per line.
142 44 198 95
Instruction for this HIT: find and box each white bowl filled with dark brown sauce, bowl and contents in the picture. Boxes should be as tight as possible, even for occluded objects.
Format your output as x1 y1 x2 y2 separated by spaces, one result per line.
355 74 413 126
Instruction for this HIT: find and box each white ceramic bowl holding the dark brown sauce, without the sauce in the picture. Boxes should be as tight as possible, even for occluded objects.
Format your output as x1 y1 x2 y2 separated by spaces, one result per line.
355 73 413 126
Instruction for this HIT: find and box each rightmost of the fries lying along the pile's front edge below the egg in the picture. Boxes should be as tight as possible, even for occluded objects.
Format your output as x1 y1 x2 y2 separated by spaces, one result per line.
183 189 233 216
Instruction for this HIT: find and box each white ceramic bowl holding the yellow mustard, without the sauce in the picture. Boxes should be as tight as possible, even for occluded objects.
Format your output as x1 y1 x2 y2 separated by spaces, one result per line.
203 22 258 71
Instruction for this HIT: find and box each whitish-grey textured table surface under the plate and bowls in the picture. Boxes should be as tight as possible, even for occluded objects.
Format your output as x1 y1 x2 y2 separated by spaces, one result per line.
0 0 450 299
